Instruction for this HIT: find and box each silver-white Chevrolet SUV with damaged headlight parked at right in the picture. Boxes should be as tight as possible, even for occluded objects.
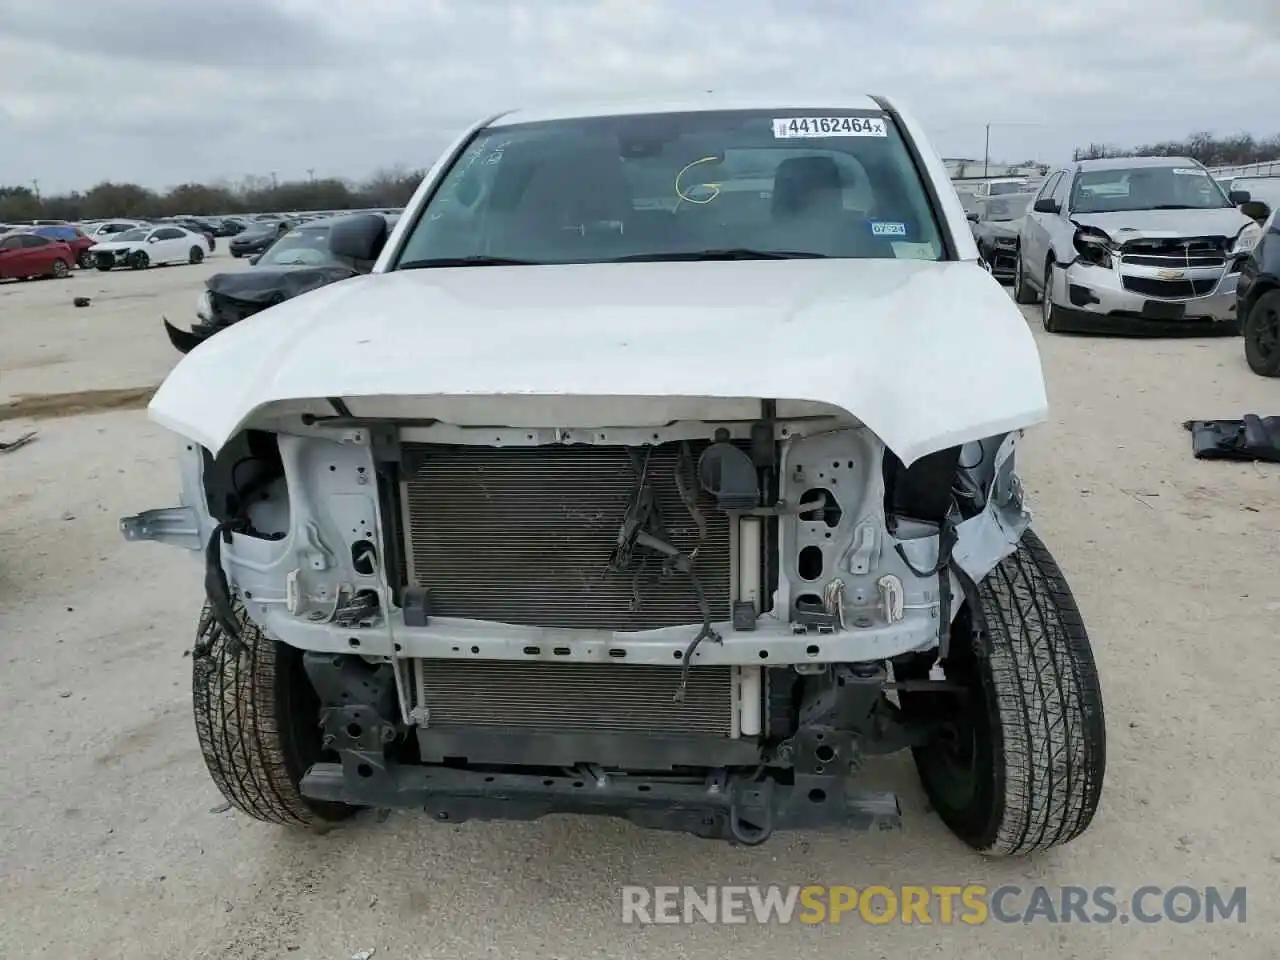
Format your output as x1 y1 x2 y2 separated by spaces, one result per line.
1014 156 1261 333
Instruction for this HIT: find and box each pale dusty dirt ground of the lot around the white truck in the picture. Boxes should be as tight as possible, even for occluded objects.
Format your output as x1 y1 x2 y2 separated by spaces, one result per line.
0 255 1280 960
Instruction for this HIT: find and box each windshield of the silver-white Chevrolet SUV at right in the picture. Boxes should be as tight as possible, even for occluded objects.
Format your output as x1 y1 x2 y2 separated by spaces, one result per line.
1070 166 1231 214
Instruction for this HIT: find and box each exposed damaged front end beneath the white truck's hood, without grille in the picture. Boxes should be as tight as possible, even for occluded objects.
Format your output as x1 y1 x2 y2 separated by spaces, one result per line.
123 399 1029 844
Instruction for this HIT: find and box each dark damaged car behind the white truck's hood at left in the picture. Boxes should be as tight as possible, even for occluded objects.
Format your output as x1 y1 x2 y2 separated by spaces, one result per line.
164 216 397 353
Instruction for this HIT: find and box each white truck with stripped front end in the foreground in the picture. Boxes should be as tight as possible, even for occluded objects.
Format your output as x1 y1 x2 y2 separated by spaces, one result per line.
122 96 1106 855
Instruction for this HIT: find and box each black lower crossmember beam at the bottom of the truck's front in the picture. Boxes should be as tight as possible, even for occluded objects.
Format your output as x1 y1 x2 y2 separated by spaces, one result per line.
302 763 901 845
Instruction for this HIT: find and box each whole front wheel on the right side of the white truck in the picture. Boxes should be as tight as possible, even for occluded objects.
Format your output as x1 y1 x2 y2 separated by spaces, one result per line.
895 530 1106 856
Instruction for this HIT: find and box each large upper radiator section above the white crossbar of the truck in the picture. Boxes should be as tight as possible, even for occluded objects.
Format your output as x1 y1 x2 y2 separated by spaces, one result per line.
402 443 732 631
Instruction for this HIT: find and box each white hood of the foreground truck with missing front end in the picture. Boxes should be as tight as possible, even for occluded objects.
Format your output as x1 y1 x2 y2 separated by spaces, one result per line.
148 260 1047 463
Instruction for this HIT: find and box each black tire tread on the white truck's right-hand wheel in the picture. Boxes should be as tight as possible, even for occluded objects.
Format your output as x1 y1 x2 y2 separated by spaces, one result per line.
975 530 1106 856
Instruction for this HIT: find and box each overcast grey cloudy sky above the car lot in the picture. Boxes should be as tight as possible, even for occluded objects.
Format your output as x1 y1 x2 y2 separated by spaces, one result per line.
0 0 1280 193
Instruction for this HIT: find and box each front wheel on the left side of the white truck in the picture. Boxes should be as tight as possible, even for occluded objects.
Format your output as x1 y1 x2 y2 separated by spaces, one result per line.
192 603 357 828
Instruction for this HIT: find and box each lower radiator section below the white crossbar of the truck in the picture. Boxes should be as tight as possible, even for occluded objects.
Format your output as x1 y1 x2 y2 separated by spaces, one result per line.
410 659 735 737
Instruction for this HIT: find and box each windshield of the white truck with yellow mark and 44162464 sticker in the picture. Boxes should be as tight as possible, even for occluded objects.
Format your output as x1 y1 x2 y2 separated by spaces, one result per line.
396 110 943 269
